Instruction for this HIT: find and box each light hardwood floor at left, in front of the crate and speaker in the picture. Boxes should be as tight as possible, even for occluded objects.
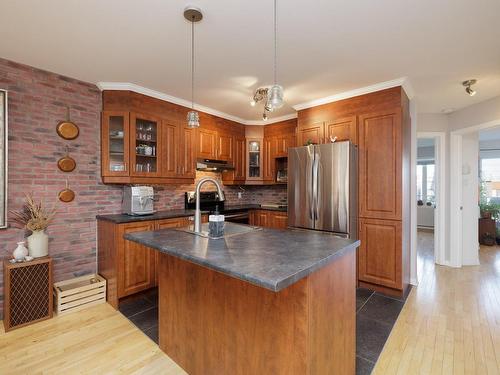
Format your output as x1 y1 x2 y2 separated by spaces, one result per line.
0 304 186 375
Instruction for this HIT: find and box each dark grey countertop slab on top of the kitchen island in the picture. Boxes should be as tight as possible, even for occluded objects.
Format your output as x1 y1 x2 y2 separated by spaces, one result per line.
124 223 360 292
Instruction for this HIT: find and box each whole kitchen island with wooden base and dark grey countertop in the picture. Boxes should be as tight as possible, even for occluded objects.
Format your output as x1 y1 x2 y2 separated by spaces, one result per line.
125 223 359 374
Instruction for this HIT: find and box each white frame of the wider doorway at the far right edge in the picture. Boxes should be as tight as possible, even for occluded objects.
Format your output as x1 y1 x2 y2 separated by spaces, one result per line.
450 119 500 267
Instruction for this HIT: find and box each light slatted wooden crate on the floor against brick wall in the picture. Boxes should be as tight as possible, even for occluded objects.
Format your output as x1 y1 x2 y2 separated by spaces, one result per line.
54 275 106 315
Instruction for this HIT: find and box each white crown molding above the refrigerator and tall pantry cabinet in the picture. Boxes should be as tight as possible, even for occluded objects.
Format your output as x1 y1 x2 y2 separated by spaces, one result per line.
293 77 414 111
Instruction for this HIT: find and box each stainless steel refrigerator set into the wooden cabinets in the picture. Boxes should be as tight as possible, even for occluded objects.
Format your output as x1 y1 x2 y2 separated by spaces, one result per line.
288 141 358 239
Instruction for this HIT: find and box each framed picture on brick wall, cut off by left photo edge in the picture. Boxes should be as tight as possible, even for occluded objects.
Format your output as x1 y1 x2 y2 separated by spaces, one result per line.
0 90 8 228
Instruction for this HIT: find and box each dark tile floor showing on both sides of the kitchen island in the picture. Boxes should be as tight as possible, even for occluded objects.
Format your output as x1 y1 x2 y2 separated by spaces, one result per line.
120 288 404 375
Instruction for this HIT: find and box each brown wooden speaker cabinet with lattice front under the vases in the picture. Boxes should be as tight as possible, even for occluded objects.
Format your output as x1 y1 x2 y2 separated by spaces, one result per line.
3 257 53 332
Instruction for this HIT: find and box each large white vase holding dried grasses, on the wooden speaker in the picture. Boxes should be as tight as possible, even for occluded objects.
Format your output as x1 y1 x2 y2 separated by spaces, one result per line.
11 194 56 258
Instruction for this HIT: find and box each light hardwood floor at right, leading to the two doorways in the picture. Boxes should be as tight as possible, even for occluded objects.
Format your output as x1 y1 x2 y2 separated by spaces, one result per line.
373 233 500 375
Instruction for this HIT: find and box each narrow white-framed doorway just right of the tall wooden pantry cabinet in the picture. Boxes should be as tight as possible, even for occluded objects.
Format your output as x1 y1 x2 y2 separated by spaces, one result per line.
416 132 446 275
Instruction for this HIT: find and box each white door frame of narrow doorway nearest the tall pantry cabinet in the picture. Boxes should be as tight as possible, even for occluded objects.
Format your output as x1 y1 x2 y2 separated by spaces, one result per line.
413 132 447 265
